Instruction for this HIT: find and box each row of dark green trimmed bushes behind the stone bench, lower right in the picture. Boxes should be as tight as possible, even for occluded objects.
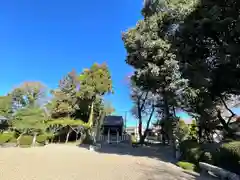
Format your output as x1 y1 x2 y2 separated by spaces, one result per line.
180 140 240 174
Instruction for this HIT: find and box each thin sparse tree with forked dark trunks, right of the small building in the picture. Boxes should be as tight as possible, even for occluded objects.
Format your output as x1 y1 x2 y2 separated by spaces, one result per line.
131 82 156 144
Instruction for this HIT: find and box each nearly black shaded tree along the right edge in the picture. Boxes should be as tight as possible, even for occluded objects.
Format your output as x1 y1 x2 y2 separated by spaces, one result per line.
172 0 240 138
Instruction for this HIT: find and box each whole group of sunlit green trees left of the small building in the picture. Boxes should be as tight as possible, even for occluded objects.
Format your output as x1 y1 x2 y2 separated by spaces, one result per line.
0 64 114 145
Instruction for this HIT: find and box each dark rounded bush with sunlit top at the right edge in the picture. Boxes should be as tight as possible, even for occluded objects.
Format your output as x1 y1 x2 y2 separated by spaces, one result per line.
213 141 240 174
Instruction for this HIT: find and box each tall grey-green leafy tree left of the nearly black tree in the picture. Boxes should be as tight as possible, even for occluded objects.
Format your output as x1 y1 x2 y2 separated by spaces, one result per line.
122 1 187 154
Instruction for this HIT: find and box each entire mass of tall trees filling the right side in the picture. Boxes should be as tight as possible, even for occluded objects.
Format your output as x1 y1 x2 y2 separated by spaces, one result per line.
122 0 240 148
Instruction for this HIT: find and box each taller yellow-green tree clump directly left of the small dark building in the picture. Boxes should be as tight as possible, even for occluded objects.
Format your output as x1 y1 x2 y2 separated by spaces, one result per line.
48 64 112 142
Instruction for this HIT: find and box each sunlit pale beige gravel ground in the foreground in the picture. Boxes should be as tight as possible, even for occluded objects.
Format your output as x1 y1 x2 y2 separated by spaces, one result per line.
0 145 214 180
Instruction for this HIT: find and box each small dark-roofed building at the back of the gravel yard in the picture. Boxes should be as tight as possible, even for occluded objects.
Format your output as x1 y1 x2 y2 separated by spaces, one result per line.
98 116 129 143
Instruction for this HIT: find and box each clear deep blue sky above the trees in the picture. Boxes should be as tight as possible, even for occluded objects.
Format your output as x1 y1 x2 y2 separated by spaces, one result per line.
0 0 238 126
